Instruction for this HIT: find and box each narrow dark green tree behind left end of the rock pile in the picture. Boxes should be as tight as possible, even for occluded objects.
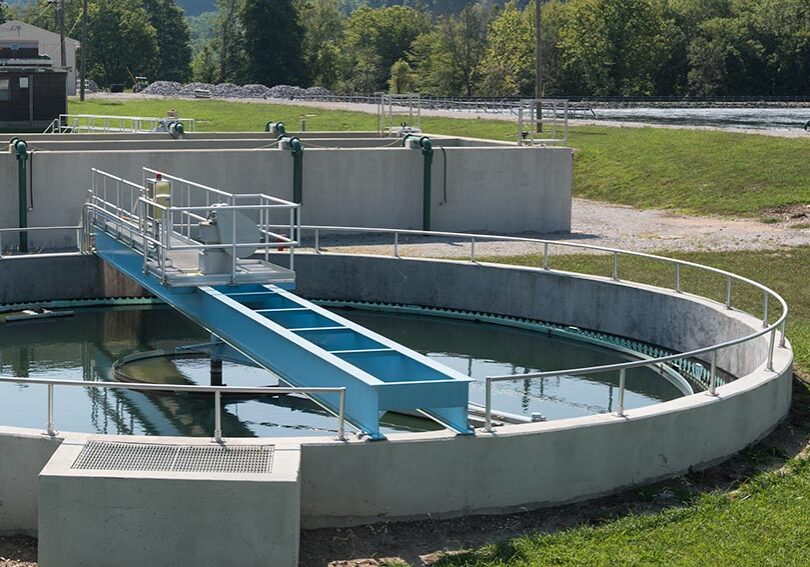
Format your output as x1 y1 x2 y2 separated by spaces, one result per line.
144 0 191 83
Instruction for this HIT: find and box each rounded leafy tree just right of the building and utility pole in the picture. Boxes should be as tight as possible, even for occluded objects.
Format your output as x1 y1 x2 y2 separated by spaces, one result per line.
87 0 158 85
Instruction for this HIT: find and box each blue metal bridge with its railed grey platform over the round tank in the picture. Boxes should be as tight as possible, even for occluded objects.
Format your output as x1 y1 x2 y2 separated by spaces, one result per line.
84 169 472 439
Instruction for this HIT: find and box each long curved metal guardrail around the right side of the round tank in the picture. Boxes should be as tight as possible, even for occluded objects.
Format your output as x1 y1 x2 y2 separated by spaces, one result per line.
0 225 789 432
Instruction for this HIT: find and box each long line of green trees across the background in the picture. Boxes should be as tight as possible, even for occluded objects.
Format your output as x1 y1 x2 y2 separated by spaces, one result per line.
6 0 810 96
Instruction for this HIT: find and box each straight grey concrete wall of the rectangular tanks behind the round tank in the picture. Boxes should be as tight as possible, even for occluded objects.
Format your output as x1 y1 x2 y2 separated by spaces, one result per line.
0 141 572 247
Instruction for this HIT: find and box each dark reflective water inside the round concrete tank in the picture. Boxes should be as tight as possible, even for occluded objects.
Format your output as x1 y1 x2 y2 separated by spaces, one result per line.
0 308 680 437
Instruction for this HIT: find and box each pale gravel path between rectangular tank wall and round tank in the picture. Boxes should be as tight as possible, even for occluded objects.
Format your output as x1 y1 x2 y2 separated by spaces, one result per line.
310 199 810 258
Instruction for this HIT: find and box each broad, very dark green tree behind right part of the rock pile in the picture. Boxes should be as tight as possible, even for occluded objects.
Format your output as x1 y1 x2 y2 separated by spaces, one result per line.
240 0 307 86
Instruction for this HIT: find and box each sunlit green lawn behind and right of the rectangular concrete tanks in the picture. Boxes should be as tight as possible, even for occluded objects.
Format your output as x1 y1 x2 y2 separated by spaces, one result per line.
70 99 810 217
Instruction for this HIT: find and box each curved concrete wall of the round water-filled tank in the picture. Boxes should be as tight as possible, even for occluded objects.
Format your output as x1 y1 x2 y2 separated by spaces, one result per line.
0 255 792 532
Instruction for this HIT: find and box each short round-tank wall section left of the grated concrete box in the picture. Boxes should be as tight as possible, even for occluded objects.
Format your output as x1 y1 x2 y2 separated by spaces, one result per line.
0 430 62 536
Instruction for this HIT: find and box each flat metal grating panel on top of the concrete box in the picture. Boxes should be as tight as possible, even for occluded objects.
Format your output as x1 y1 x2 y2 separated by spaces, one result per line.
71 441 273 474
